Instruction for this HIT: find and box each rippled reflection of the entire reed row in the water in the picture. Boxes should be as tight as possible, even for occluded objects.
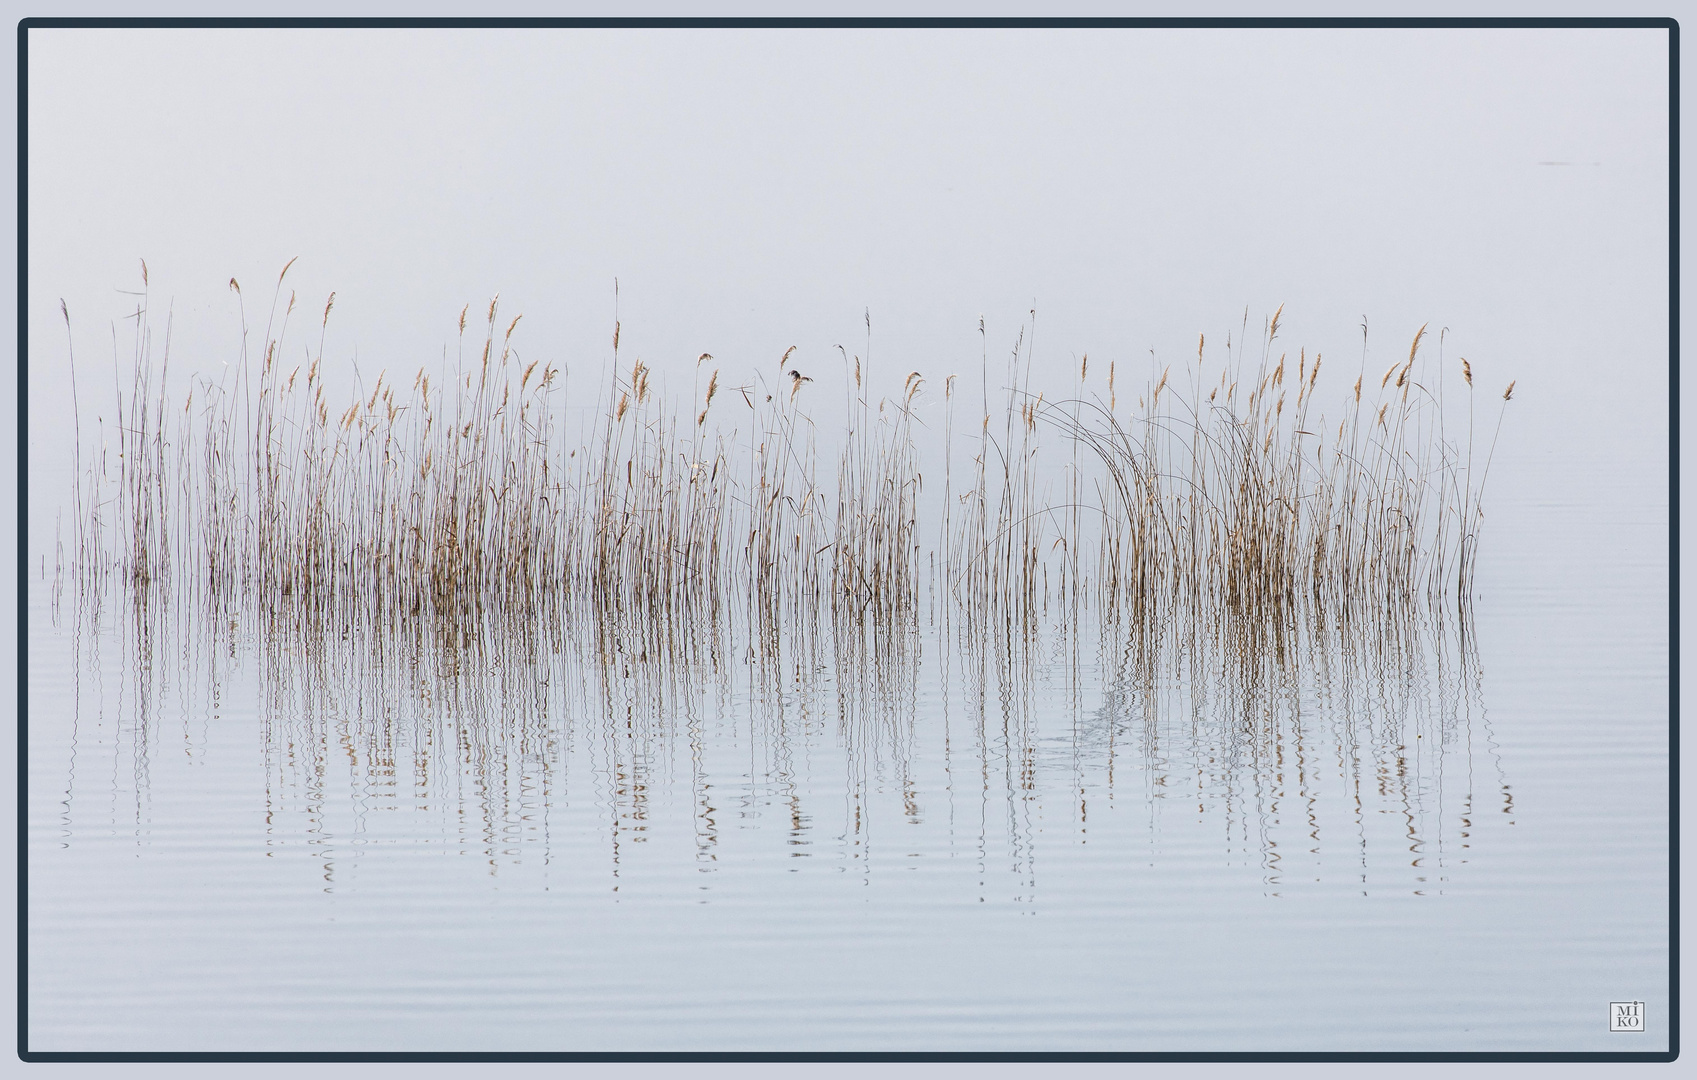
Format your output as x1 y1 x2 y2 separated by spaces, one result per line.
53 546 1512 910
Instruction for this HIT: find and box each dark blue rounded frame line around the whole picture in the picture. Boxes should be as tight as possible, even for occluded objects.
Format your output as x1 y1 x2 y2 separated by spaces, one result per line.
17 19 1680 1063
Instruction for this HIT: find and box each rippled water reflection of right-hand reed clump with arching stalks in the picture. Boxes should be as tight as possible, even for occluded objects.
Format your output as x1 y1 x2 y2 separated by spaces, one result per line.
1083 597 1512 892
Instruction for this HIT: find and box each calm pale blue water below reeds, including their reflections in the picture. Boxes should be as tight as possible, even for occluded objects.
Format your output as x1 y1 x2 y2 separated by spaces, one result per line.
29 455 1668 1051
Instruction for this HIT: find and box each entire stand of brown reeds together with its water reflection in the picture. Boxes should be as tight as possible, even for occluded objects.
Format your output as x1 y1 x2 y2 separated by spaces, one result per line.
53 268 1512 897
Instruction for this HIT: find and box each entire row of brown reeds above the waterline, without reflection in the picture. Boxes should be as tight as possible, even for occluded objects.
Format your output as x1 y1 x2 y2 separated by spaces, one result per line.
66 268 1512 657
